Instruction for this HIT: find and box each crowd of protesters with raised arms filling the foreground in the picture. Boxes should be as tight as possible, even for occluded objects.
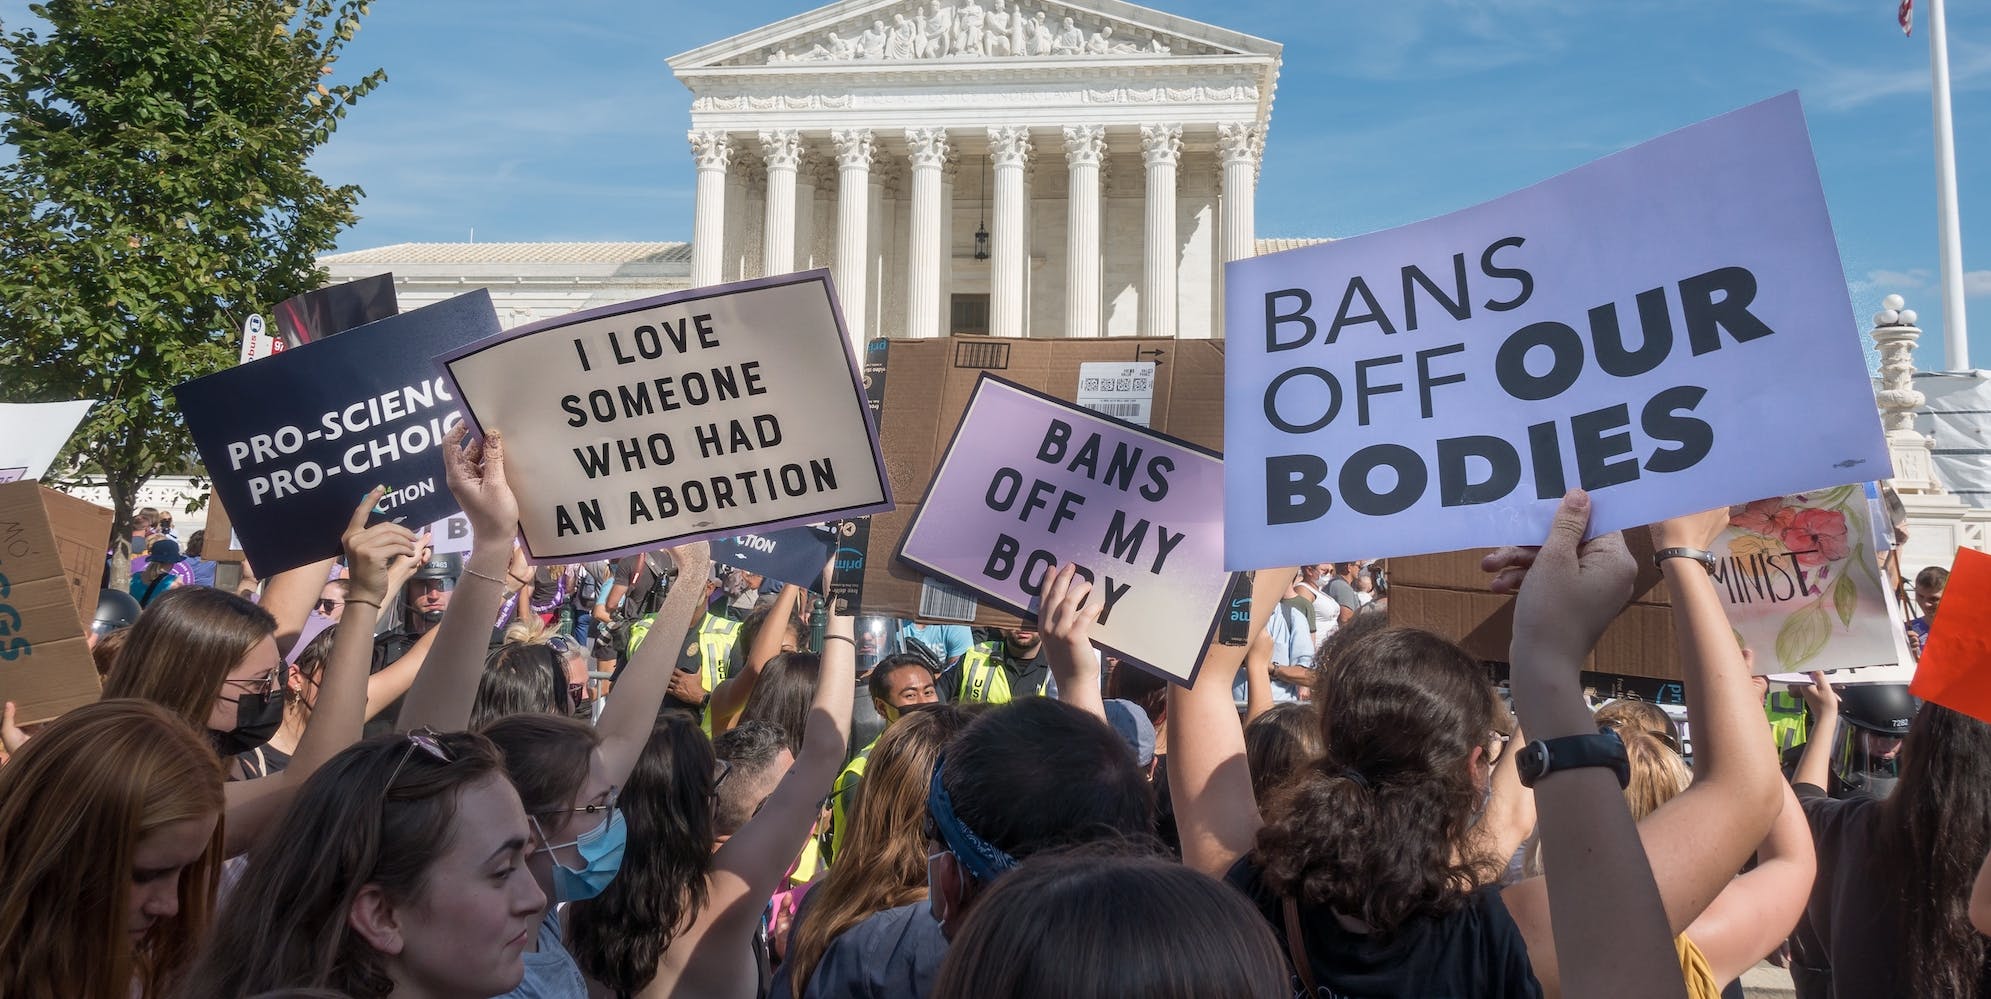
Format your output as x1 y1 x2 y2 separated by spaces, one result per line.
0 423 1991 999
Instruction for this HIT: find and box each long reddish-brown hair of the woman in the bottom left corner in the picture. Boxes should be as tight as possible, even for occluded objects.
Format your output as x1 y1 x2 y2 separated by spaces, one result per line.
0 699 225 999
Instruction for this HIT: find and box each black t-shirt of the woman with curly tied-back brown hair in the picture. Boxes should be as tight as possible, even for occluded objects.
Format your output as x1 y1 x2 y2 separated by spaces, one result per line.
1224 856 1541 999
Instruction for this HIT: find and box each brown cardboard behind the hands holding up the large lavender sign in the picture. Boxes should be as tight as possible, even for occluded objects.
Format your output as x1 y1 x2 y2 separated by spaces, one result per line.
1388 529 1680 681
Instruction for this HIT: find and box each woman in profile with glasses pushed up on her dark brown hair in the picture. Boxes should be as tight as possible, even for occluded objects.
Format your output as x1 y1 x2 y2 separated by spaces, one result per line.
179 730 546 999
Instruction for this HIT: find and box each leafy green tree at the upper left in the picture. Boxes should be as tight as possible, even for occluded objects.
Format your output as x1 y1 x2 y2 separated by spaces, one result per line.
0 0 386 561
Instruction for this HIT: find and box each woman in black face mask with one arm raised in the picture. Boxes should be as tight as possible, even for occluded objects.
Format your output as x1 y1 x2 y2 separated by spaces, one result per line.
104 490 416 856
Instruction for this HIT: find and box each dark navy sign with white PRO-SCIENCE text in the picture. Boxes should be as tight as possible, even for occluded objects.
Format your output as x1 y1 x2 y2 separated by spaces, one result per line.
175 289 498 577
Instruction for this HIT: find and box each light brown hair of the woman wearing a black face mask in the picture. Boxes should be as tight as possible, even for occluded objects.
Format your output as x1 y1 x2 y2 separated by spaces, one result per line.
104 587 277 732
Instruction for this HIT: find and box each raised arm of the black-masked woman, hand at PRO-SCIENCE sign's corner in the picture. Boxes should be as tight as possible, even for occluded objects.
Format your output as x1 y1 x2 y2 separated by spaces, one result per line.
225 488 416 856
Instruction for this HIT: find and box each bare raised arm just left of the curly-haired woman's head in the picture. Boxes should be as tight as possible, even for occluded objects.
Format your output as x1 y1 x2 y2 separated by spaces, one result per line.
1169 567 1294 878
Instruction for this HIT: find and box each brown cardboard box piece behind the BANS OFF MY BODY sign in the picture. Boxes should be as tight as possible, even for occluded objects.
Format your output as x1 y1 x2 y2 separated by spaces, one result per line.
858 336 1224 627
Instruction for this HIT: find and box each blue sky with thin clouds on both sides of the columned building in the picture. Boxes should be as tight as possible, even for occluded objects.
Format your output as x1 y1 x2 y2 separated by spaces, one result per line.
0 0 1991 366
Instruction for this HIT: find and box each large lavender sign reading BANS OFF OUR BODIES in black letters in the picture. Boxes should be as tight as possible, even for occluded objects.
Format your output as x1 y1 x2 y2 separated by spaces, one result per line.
1224 94 1887 569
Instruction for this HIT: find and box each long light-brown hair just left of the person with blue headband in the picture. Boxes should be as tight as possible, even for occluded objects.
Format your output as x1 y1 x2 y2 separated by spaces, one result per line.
774 704 974 995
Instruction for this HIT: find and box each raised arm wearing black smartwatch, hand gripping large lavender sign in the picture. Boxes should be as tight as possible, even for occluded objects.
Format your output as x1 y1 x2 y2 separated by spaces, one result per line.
1483 490 1680 999
